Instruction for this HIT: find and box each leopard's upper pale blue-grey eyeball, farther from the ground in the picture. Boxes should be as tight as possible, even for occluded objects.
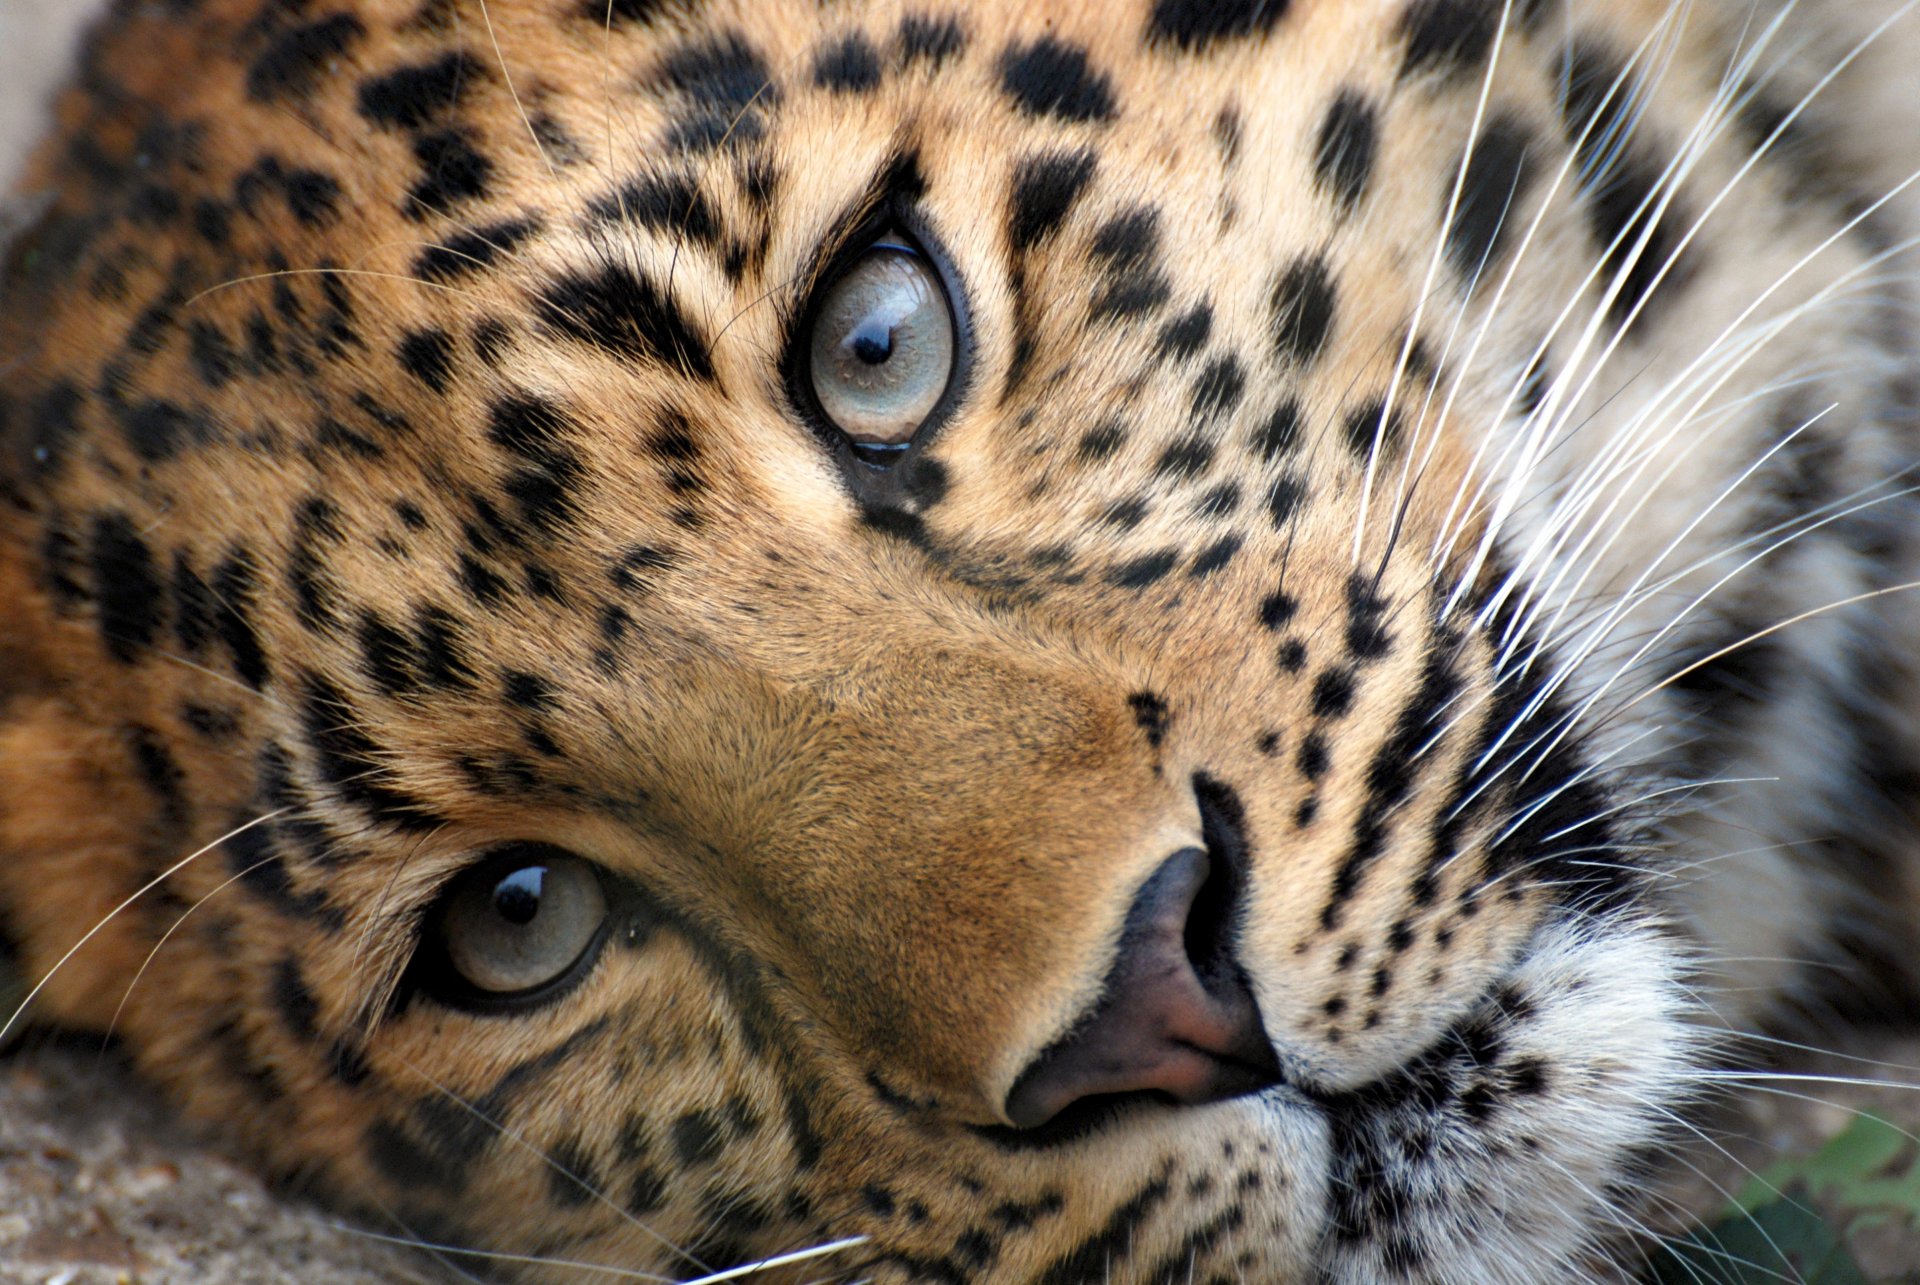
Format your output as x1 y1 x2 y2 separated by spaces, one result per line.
808 240 954 451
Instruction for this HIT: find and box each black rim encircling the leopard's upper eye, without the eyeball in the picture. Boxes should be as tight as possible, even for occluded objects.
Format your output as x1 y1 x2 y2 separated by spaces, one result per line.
781 200 973 480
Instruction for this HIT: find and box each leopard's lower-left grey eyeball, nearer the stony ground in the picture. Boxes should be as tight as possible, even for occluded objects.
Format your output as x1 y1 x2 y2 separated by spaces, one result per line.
432 843 607 999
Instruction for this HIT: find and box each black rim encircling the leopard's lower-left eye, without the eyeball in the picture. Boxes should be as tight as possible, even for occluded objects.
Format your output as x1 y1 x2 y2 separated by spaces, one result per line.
399 839 614 1016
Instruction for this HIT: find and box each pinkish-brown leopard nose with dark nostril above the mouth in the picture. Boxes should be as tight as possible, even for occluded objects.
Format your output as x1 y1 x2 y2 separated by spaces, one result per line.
1006 847 1279 1129
